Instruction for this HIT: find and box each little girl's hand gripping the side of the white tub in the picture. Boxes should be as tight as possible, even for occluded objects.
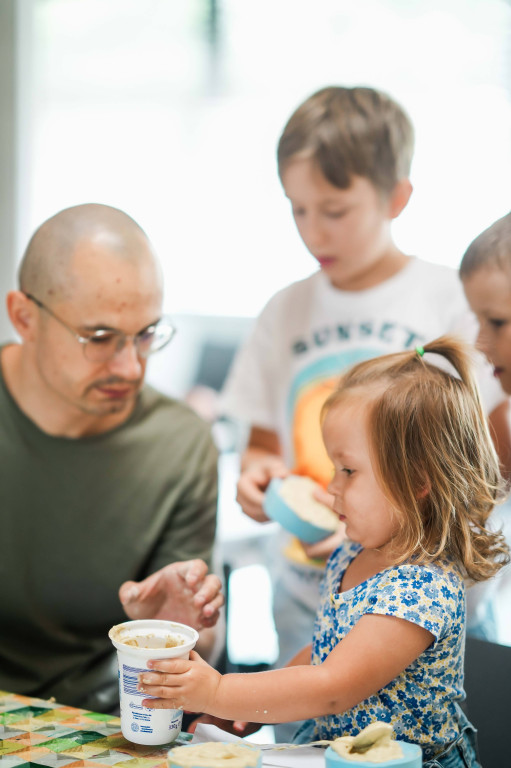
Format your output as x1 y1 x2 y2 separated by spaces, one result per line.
138 651 222 712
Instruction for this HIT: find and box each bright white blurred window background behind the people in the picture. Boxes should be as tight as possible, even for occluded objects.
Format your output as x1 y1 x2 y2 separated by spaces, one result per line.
26 0 511 676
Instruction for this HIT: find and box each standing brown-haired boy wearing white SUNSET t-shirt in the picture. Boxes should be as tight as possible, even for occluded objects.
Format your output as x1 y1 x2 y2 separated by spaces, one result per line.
223 87 506 736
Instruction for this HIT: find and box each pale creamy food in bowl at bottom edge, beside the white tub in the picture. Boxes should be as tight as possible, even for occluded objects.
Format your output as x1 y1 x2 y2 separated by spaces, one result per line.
167 741 262 768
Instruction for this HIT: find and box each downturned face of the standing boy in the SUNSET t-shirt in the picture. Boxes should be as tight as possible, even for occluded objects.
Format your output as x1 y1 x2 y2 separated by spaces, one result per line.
282 159 401 291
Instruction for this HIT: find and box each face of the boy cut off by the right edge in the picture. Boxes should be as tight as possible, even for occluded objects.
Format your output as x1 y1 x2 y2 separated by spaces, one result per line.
463 266 511 395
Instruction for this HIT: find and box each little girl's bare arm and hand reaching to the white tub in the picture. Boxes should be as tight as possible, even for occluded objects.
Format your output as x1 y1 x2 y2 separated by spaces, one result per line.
139 614 433 723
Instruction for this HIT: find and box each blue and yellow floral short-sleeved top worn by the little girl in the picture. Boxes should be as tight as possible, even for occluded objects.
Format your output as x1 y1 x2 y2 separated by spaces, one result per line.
312 541 465 759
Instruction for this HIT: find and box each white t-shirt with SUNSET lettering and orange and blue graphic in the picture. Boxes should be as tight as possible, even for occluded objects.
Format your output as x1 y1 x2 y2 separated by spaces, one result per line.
222 259 504 485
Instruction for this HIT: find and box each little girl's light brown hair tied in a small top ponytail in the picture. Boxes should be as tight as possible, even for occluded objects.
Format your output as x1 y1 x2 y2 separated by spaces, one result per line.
322 336 509 581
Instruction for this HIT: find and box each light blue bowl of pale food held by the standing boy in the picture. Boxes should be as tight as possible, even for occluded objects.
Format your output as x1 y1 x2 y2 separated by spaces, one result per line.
263 475 339 544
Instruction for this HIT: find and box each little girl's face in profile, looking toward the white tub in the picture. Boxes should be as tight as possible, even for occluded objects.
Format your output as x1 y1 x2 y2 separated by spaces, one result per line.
323 399 399 551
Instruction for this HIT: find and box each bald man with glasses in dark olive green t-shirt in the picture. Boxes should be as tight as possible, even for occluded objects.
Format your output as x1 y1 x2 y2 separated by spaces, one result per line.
0 205 223 712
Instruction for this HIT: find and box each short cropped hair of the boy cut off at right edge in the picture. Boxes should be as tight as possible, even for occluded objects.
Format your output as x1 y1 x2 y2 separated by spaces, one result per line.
460 212 511 280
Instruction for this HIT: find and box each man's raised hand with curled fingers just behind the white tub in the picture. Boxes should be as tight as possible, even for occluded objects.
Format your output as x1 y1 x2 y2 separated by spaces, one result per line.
119 560 224 630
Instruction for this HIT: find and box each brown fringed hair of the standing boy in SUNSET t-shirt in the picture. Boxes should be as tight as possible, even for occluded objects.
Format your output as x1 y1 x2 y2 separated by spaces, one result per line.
277 86 414 194
